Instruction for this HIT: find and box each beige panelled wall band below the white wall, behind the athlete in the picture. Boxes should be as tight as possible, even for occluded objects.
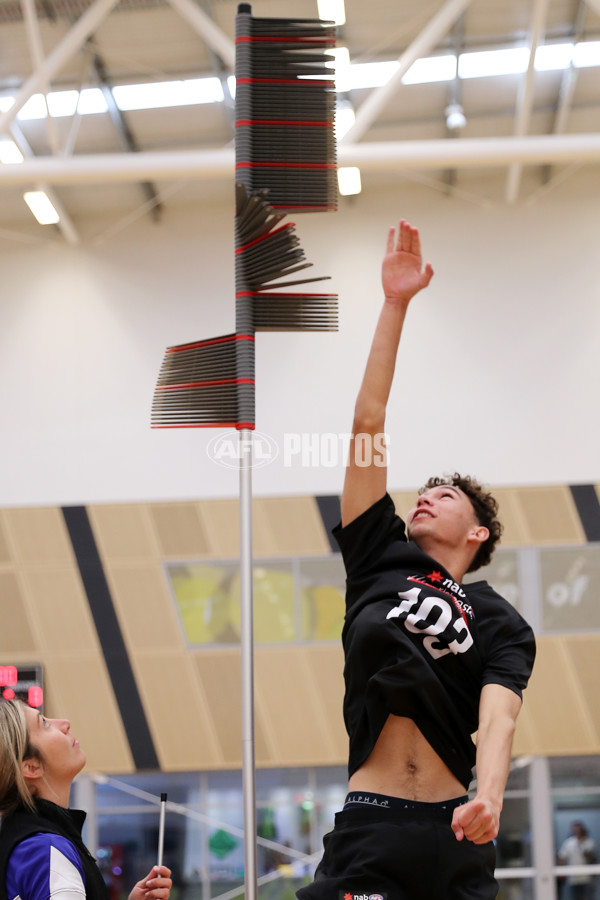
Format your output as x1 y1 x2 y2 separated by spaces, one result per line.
0 486 600 772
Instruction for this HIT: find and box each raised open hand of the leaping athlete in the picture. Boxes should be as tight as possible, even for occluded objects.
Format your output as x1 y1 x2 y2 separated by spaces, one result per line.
381 219 433 303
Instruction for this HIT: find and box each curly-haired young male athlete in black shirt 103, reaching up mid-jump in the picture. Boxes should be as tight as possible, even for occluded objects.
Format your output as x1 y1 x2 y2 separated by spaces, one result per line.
298 220 535 900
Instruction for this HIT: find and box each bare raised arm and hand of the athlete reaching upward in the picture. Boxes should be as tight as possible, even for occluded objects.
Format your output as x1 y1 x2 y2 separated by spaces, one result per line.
342 219 433 525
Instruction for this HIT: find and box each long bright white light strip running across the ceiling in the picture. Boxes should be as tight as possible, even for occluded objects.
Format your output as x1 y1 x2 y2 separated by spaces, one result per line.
0 41 600 120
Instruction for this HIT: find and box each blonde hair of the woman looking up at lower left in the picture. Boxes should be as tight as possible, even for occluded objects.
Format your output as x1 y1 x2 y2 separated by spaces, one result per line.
0 700 40 816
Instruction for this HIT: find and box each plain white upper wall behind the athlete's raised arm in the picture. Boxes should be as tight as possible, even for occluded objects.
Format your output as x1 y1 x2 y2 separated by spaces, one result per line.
0 169 600 505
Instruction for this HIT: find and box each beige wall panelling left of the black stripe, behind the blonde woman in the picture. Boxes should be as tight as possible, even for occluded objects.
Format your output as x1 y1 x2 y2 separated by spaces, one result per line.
0 508 133 772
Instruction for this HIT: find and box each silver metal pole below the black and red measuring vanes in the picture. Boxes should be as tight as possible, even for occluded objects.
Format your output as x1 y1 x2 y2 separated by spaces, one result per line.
239 428 258 900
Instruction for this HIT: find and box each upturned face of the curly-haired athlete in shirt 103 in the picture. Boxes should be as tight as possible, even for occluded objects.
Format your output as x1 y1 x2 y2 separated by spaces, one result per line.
406 484 481 549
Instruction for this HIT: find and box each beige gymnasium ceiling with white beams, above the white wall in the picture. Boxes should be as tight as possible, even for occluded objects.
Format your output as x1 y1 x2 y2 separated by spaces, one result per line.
0 0 600 242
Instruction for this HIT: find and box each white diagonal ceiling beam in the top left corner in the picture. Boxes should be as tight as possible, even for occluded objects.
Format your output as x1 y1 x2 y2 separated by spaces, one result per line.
0 0 118 134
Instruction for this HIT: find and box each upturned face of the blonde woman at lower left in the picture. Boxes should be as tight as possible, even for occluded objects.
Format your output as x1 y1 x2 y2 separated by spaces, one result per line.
25 707 85 784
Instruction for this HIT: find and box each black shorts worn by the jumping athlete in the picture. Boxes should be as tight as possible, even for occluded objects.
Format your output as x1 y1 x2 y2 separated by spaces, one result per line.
297 793 498 900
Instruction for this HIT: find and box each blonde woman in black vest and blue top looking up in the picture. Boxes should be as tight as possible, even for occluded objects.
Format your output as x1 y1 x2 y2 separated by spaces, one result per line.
0 700 172 900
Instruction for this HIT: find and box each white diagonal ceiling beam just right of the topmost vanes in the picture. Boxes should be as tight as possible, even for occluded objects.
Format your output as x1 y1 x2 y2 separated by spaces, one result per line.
342 0 472 144
